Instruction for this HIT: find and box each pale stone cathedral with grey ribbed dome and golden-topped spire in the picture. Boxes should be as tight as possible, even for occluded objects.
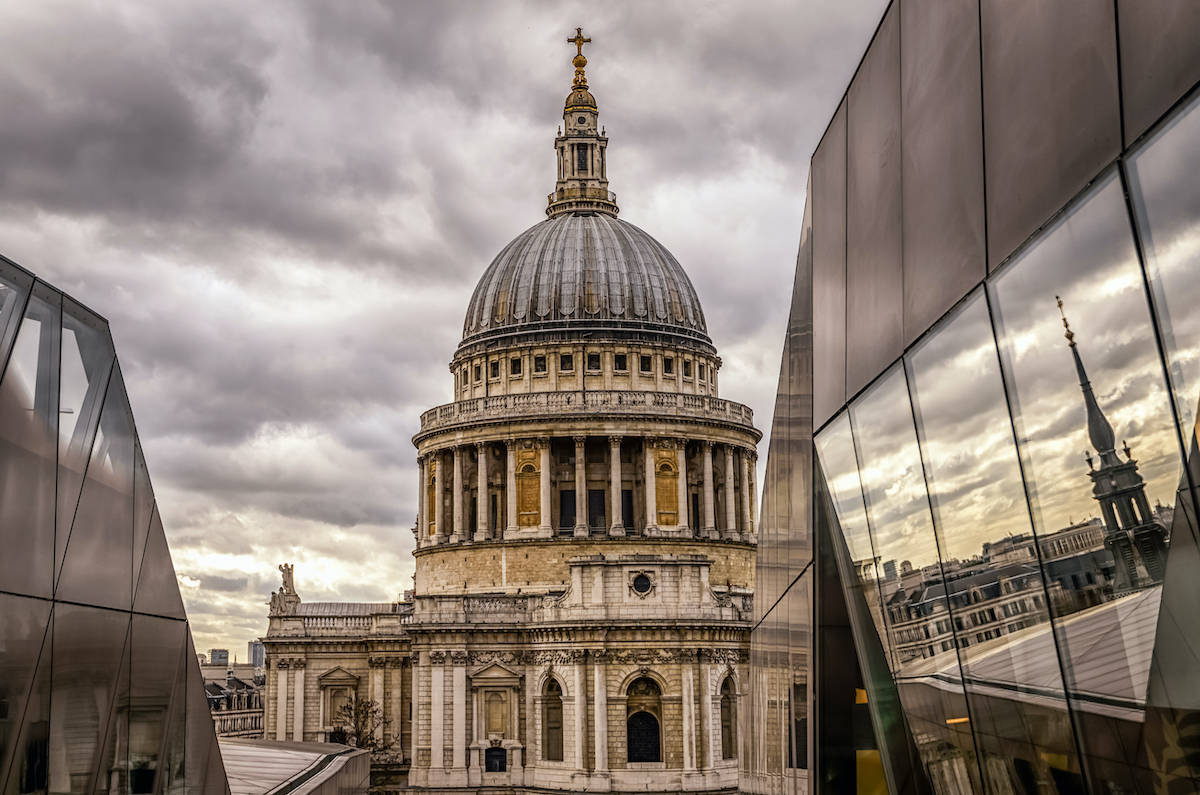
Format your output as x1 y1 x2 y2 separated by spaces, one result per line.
264 31 760 793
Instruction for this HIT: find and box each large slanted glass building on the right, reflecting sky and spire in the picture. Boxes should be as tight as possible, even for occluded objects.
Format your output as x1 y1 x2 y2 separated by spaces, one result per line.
742 0 1200 795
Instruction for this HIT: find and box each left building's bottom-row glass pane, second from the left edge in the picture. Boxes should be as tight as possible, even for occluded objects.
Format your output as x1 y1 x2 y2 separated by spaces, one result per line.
49 603 130 793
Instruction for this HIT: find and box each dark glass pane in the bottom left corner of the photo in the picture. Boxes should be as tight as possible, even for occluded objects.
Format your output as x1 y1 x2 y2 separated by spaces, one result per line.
0 594 50 793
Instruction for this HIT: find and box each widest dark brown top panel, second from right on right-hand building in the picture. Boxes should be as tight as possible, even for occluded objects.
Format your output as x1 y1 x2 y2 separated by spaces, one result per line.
980 0 1121 267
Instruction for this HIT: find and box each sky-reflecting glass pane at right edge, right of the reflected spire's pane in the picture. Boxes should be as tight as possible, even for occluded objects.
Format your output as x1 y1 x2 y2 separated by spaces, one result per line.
1129 98 1200 441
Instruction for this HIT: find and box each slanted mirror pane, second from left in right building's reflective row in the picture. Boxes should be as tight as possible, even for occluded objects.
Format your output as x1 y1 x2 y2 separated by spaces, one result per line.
850 366 979 793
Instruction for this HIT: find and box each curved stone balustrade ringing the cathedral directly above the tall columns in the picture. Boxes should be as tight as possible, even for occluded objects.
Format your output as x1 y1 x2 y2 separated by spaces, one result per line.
420 389 754 434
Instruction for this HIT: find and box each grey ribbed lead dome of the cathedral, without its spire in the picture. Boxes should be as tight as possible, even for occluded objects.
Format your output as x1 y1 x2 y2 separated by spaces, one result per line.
453 213 712 349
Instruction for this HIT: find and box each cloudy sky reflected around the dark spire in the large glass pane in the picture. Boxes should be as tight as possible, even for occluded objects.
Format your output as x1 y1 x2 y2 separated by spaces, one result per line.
992 170 1180 533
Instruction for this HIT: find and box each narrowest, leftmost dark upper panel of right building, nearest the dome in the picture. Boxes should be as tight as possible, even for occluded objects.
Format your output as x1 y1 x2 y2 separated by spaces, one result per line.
809 102 846 425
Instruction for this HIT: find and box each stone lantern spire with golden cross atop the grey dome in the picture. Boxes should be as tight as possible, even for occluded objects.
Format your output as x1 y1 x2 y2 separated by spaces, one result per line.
546 28 618 217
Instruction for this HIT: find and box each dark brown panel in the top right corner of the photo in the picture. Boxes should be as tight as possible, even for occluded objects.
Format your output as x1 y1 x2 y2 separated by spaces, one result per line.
1117 0 1200 144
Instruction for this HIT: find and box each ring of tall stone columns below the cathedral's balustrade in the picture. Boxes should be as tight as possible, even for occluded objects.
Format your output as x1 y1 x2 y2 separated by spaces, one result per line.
418 436 757 545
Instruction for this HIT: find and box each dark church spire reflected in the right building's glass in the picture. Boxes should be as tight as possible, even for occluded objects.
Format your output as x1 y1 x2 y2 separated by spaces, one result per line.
1055 295 1166 591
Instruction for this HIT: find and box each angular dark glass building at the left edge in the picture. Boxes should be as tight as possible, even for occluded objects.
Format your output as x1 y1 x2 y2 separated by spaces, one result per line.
0 258 229 795
